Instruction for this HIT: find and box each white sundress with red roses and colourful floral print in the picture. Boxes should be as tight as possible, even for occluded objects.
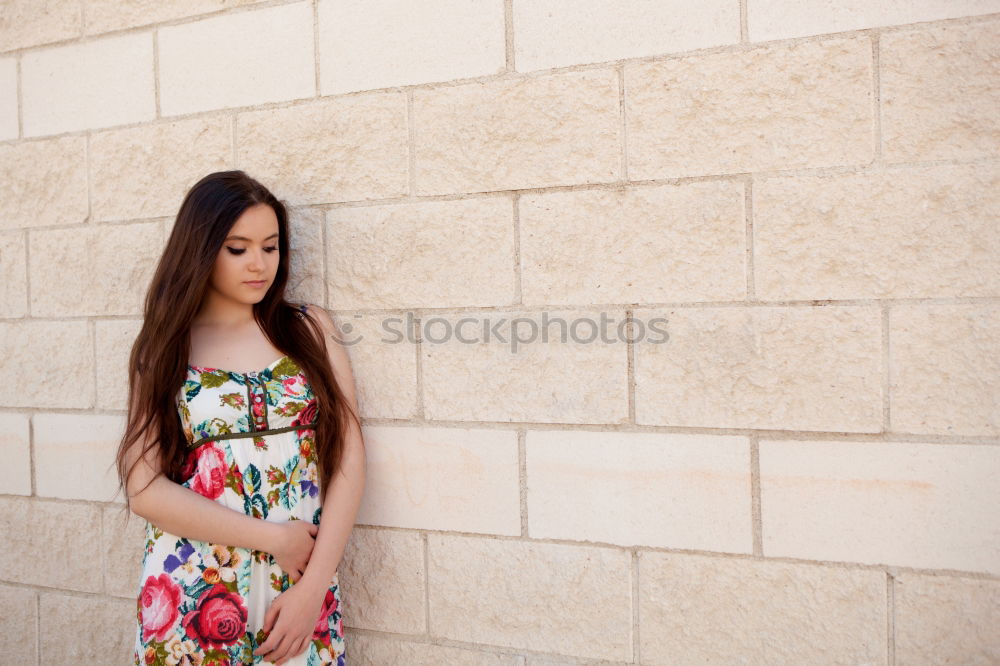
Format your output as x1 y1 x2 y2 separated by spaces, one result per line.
133 326 346 666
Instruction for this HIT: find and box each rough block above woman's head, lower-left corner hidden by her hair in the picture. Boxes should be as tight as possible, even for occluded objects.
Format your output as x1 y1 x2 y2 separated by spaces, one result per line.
236 93 408 205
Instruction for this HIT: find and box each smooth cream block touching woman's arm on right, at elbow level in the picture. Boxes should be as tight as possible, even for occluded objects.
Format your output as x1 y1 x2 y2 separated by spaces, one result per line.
358 426 521 536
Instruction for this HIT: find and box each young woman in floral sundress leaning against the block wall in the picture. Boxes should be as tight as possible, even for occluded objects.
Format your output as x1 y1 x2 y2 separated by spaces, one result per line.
117 171 365 666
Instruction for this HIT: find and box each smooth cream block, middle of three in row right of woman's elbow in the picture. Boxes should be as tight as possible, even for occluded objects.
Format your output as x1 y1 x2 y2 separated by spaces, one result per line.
525 430 753 553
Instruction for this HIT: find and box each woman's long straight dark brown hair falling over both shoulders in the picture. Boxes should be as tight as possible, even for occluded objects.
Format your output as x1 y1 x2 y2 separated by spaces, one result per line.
116 170 360 509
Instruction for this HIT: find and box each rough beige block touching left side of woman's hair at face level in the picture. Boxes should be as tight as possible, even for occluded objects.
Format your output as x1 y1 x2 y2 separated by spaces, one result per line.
28 222 164 317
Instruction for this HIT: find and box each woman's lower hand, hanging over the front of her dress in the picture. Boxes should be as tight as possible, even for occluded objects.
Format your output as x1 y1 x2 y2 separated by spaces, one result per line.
253 585 326 664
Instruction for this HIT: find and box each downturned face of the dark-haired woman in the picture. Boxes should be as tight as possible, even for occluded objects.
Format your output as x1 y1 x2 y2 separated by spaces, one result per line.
209 204 278 304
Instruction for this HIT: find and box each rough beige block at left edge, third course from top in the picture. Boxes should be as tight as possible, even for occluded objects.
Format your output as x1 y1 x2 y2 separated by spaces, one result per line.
0 136 88 229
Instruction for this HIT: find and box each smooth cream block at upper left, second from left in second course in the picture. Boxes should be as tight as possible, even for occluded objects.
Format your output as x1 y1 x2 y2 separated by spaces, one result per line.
21 32 154 136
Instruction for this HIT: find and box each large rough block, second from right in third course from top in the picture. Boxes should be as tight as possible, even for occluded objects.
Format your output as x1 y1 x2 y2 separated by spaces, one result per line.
625 36 874 180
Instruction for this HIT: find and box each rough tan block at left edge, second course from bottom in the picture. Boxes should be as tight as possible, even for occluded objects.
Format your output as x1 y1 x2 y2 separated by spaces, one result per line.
0 497 102 588
